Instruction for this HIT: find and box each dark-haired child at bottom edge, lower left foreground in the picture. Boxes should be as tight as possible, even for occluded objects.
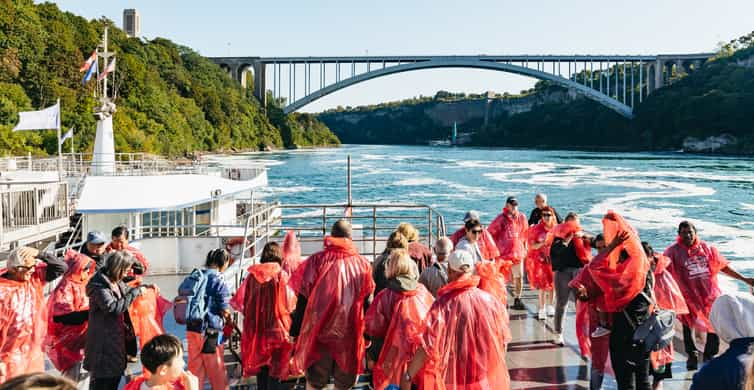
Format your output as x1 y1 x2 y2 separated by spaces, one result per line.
123 334 199 390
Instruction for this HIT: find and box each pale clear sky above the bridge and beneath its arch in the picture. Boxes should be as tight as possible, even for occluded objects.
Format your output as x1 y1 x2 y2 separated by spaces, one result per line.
56 0 754 111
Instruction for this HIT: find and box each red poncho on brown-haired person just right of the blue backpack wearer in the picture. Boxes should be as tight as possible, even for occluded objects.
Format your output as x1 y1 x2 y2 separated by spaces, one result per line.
230 263 296 380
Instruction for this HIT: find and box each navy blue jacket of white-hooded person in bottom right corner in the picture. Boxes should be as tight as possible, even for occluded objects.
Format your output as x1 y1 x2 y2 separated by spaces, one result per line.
691 337 754 390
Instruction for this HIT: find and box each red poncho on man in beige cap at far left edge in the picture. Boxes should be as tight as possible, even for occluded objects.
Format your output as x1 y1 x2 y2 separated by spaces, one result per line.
0 263 47 383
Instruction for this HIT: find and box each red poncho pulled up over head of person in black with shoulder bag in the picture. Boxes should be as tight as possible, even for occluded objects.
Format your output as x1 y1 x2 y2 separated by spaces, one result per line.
587 211 649 313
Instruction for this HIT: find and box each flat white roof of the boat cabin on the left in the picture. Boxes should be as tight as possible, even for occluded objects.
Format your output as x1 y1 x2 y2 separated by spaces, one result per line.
76 174 258 214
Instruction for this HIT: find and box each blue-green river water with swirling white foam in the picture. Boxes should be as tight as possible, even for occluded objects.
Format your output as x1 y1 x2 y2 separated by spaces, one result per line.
217 145 754 284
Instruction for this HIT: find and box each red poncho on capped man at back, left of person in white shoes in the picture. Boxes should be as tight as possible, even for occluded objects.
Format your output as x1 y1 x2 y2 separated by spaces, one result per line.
487 209 529 264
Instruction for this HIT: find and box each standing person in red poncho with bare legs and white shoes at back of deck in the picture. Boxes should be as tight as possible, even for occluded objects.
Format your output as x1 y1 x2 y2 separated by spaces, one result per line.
514 206 562 322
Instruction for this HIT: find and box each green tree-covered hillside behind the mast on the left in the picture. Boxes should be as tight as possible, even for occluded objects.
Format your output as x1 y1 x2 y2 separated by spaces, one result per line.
0 0 336 156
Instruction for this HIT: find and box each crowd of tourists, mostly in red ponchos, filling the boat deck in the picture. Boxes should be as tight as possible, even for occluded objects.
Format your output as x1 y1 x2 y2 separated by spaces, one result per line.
0 194 754 390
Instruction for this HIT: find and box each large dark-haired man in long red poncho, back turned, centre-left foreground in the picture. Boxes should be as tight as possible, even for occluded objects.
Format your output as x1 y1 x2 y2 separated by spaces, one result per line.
290 220 374 389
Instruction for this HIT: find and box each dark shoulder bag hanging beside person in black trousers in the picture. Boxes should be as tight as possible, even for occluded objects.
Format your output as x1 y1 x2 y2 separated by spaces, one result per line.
623 292 676 352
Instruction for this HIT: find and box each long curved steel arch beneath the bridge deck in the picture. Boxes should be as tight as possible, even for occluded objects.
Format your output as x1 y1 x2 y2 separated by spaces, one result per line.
283 58 633 119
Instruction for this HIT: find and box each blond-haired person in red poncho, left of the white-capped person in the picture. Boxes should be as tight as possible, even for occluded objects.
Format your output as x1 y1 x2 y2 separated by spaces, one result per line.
364 249 434 389
